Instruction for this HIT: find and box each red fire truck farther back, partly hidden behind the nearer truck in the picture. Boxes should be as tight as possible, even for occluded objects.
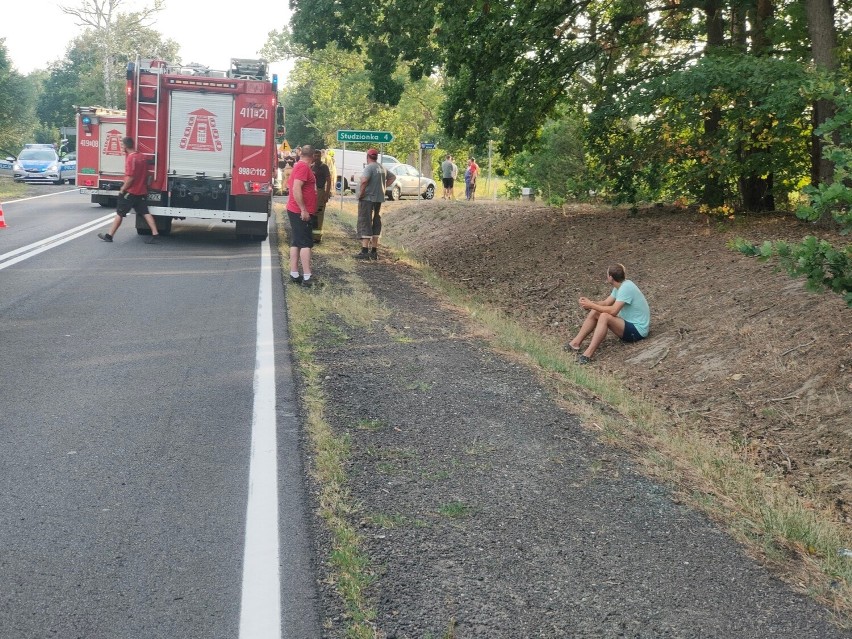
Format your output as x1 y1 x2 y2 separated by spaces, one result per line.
76 106 127 207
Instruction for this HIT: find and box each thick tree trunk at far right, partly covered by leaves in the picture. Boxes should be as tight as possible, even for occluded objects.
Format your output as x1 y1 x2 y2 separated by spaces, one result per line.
805 0 838 185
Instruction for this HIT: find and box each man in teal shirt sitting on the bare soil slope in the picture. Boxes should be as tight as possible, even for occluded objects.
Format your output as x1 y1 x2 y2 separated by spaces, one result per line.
568 264 651 364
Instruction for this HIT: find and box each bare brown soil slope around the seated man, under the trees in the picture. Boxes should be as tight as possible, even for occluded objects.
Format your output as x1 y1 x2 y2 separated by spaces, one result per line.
383 201 852 523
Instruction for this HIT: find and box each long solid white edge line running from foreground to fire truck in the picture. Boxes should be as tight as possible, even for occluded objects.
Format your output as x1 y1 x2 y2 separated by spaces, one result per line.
240 242 281 639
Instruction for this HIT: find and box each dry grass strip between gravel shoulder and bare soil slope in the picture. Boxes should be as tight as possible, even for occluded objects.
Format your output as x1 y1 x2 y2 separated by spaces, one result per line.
322 206 852 629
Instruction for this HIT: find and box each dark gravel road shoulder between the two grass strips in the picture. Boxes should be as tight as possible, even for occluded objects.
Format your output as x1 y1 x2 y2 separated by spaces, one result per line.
288 212 849 638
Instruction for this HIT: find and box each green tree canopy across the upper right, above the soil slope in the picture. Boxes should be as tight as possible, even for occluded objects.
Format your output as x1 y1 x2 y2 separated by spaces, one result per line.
291 0 852 209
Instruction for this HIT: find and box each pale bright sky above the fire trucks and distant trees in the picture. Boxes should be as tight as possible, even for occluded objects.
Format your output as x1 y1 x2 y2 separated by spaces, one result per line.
0 0 290 86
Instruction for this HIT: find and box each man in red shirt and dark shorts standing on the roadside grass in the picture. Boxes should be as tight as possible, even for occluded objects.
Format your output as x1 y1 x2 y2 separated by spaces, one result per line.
287 144 317 286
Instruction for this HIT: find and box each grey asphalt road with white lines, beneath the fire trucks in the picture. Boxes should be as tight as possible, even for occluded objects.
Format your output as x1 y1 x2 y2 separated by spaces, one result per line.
0 187 319 639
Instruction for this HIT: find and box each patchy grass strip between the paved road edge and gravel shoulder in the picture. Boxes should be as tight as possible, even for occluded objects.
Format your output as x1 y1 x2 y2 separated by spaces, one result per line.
277 206 387 639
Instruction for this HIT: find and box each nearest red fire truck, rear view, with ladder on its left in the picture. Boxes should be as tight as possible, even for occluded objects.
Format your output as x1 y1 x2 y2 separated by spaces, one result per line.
127 58 283 240
